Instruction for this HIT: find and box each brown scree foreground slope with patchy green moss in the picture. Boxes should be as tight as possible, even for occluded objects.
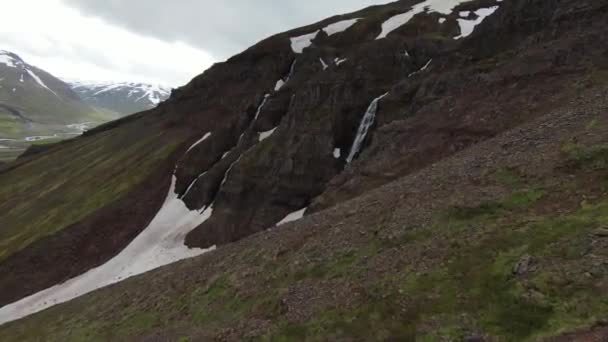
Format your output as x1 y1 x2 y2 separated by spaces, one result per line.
0 90 608 341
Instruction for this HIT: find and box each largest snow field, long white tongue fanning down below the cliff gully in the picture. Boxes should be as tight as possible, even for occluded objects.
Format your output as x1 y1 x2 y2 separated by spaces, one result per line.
0 134 215 324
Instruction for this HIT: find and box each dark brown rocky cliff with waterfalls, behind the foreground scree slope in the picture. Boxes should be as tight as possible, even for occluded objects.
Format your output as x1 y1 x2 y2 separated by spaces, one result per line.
0 0 608 332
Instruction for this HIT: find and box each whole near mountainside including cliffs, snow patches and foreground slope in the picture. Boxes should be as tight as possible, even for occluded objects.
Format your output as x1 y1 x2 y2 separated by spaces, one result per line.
0 0 608 341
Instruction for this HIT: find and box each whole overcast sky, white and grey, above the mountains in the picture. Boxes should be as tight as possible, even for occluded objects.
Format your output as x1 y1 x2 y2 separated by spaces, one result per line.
0 0 390 87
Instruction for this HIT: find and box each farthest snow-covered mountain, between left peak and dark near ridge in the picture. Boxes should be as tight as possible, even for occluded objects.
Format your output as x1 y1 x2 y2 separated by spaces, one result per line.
67 80 171 114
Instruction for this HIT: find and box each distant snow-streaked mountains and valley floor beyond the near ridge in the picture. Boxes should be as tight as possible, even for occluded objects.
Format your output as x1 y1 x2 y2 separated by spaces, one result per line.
0 50 171 160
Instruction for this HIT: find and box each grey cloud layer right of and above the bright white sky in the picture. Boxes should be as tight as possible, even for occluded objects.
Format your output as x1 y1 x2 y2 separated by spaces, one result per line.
64 0 390 59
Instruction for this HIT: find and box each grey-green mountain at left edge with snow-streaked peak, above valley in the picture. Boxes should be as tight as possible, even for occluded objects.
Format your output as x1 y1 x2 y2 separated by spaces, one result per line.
0 50 118 159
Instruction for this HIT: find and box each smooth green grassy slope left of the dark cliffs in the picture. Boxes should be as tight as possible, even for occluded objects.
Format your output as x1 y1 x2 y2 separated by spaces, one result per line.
0 115 180 260
